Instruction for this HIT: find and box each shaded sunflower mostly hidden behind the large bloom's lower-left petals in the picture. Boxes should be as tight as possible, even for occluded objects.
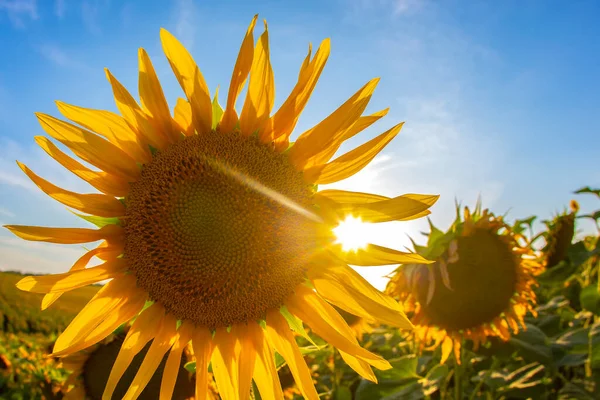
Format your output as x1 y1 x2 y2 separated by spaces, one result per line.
61 332 196 400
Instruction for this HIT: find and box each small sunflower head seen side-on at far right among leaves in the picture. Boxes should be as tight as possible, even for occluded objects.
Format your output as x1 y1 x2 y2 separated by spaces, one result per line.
542 200 579 268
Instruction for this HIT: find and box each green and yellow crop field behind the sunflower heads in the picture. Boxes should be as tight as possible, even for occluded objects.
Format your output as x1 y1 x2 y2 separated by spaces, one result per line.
0 189 600 400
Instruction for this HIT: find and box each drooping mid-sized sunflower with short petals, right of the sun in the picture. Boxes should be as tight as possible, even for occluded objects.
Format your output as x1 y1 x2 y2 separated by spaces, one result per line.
386 204 541 363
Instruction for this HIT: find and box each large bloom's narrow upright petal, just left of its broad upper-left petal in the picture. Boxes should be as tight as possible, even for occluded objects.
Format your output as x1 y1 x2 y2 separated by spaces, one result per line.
138 48 181 142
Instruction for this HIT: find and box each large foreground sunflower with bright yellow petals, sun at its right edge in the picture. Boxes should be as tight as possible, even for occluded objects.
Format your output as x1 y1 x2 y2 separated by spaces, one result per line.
7 16 438 399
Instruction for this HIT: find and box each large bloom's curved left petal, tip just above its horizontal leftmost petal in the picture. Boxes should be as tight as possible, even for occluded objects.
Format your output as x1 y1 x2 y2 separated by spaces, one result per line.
17 161 125 217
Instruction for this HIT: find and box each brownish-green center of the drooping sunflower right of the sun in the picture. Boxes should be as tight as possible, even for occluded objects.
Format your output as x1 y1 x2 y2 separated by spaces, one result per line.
417 229 519 331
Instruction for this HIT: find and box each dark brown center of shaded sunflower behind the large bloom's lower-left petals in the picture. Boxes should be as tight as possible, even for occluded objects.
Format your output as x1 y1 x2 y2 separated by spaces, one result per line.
81 334 194 400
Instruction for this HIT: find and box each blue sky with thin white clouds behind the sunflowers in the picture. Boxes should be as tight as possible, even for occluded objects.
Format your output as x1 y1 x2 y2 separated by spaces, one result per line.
0 0 600 287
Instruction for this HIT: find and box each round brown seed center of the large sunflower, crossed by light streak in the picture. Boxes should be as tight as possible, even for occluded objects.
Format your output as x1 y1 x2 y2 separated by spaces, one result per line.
125 132 318 328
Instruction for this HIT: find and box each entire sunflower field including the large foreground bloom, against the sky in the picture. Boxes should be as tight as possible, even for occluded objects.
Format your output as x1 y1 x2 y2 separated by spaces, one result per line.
0 15 600 400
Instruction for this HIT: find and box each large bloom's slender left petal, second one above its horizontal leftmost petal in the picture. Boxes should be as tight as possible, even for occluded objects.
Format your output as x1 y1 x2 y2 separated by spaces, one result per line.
35 136 129 197
